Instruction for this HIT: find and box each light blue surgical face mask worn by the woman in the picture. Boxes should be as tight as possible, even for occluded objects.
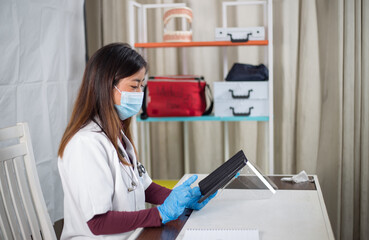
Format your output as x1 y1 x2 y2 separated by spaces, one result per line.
114 86 143 120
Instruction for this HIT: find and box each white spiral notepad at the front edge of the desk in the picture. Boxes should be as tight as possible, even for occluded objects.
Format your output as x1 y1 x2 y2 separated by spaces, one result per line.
183 228 259 240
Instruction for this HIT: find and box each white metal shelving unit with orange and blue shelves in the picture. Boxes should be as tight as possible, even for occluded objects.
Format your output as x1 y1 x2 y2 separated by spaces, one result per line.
128 0 274 174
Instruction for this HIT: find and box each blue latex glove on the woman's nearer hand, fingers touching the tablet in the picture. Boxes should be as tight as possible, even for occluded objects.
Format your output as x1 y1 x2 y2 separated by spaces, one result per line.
158 175 197 224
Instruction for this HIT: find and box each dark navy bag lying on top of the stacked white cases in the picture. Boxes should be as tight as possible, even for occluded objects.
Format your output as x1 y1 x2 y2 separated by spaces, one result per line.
226 63 269 81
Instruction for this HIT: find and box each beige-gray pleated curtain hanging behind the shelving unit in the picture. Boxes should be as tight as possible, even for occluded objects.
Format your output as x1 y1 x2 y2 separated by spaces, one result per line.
86 0 369 239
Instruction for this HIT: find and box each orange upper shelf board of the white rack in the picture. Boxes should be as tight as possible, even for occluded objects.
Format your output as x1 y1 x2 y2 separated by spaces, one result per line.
134 40 268 48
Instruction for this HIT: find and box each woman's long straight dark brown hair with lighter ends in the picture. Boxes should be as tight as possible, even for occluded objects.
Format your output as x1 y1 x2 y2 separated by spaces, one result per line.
58 43 147 164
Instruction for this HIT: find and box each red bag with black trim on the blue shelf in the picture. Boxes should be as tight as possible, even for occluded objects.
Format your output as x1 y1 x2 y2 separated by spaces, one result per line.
141 75 213 119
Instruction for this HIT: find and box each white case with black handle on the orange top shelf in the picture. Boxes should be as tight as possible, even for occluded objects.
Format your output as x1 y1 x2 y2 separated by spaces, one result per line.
215 27 265 41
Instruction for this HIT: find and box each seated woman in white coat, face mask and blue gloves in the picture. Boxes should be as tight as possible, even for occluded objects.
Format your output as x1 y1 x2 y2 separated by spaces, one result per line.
58 43 213 239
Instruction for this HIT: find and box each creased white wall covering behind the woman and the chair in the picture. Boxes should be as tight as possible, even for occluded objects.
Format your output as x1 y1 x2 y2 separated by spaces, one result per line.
0 0 85 221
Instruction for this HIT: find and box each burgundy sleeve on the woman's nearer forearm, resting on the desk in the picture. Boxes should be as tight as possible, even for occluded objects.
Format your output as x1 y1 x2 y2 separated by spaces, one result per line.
87 207 161 235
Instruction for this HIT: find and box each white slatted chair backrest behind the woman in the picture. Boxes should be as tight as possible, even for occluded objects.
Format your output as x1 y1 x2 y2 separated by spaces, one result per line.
0 123 56 240
